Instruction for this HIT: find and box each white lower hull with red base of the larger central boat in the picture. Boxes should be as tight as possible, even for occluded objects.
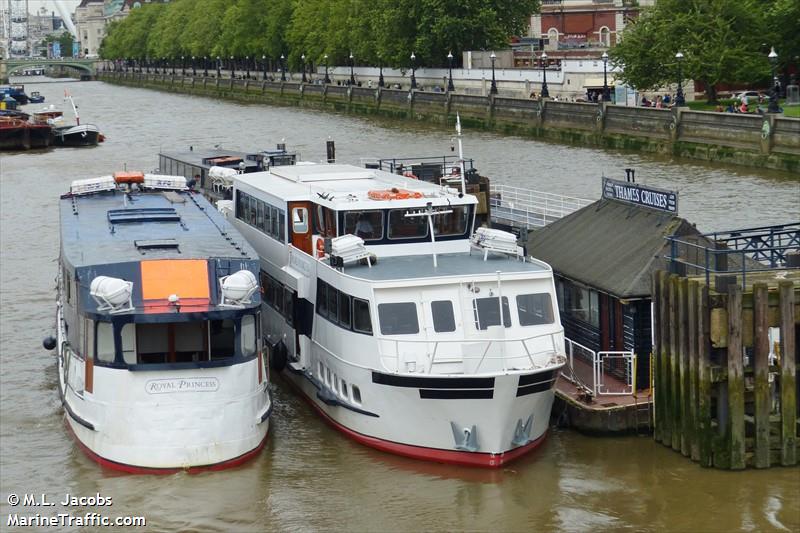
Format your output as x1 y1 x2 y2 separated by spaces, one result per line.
281 358 554 468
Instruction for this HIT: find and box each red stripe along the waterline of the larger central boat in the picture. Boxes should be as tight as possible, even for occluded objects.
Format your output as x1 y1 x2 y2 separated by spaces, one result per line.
284 379 547 468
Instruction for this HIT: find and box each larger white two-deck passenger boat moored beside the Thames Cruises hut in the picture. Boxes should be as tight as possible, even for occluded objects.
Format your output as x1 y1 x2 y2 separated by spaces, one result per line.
218 145 565 467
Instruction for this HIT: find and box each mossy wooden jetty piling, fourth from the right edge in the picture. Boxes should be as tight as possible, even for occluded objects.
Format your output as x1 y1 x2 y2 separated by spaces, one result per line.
696 285 714 466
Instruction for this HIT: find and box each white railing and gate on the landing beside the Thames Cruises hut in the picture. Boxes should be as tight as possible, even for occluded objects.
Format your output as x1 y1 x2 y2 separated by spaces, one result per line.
561 339 636 396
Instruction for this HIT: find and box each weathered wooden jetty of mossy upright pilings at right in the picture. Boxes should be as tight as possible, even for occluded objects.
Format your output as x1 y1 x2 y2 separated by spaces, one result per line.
653 270 800 470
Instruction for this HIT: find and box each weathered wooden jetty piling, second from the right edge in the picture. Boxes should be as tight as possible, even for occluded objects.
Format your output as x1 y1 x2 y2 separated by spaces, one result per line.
753 283 771 468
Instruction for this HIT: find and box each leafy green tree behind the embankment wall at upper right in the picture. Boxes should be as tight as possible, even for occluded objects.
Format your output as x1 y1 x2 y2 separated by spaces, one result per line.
609 0 769 103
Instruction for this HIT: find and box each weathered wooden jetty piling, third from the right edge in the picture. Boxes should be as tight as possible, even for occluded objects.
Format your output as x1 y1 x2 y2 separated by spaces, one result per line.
728 283 747 470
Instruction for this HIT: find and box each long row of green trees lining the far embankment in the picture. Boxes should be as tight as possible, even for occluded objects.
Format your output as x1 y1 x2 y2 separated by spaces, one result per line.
100 0 540 68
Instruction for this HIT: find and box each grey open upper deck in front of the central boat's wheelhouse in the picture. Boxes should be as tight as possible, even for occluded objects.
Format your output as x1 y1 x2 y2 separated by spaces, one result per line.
344 250 550 281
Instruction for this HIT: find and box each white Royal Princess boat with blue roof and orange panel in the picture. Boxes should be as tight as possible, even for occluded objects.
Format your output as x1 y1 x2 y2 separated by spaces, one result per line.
50 172 272 473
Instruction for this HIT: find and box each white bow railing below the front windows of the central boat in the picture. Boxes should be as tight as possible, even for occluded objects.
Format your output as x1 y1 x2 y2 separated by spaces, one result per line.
377 331 566 375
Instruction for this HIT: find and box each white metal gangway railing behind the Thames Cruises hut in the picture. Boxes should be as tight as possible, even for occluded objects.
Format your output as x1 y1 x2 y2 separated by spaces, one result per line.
489 181 592 229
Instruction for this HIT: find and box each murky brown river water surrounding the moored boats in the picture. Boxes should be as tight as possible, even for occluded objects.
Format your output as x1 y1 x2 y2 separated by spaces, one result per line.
0 78 800 531
